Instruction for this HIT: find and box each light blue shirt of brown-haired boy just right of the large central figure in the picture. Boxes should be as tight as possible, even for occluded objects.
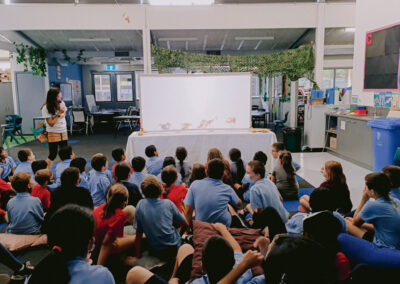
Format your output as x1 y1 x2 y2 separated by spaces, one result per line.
250 178 289 223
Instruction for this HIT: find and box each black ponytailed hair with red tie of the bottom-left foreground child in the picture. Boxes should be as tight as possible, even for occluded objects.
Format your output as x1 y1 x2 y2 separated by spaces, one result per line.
28 204 95 284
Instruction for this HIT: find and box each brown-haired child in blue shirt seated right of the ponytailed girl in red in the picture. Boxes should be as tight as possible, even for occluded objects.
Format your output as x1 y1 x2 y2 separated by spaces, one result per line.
134 175 186 261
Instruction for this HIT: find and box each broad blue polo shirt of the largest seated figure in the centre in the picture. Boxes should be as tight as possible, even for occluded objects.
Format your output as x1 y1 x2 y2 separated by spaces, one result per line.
183 177 239 227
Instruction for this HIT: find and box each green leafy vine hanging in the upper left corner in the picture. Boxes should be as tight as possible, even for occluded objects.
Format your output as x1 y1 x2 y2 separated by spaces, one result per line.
14 42 47 77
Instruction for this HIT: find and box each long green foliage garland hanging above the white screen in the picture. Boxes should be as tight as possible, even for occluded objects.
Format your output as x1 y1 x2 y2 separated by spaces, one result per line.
152 45 314 82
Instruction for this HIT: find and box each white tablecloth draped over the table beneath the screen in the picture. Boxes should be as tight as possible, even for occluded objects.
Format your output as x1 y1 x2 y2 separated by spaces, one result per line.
126 130 277 171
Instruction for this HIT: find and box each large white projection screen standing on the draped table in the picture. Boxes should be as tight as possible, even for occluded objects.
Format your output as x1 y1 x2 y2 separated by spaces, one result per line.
139 73 251 131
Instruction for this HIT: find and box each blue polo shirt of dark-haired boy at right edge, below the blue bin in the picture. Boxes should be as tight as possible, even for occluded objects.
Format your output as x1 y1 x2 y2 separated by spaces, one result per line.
359 197 400 249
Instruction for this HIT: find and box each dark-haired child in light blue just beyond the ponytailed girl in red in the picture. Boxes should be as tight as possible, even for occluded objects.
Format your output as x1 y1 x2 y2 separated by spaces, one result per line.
89 153 111 206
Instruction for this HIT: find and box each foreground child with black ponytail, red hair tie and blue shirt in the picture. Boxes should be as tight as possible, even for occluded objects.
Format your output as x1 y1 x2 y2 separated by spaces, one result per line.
25 204 115 284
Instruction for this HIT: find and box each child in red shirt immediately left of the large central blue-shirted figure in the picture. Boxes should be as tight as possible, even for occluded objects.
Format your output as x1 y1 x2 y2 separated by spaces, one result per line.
161 165 188 213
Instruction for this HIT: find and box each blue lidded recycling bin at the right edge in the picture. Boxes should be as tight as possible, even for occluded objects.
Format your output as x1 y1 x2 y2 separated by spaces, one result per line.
368 118 400 172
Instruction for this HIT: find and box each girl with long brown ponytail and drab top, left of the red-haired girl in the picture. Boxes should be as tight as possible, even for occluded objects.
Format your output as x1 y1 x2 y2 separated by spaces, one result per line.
271 151 299 200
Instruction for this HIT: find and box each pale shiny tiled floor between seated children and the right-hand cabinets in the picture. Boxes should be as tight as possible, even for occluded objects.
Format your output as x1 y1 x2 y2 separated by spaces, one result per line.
292 152 371 209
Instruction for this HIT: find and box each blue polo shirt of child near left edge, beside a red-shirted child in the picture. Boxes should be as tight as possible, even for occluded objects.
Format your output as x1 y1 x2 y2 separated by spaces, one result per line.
7 192 43 235
